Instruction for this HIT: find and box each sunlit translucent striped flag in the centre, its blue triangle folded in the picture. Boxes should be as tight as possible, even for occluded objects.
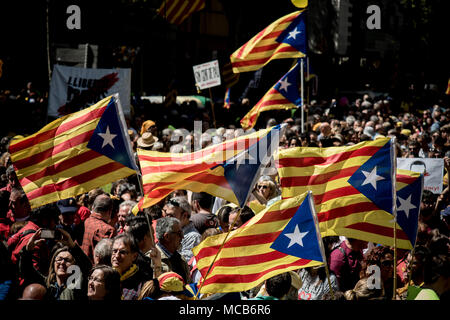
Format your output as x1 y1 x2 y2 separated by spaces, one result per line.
133 125 285 212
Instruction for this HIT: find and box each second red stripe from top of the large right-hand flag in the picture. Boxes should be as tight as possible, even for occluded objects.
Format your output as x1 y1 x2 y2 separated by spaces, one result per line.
282 166 360 188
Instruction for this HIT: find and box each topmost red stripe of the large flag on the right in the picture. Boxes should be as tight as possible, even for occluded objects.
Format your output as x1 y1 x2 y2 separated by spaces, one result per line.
277 146 382 168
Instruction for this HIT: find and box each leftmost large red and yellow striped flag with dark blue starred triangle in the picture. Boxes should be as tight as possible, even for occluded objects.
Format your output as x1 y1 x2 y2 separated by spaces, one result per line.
9 95 138 208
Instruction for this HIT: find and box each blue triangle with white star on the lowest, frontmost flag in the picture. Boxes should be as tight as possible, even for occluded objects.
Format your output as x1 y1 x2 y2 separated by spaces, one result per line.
270 194 323 262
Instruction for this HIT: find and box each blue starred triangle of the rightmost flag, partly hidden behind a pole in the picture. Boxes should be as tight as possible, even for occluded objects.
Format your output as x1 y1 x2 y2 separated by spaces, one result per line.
397 175 423 247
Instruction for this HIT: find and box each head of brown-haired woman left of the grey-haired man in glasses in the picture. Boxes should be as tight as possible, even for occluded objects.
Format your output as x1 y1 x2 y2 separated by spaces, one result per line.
111 232 139 274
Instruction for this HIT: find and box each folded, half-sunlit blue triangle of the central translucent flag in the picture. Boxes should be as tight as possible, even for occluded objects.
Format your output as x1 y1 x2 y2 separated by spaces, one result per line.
222 125 281 208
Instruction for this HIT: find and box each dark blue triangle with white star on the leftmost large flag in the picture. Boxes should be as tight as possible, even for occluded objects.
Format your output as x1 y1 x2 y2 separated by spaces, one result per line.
87 98 136 170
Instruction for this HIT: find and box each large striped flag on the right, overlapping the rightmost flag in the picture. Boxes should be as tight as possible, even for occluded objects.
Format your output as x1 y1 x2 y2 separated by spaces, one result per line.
276 138 412 249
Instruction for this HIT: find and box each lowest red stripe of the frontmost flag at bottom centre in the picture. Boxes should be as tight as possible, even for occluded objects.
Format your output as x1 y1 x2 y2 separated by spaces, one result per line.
200 258 311 285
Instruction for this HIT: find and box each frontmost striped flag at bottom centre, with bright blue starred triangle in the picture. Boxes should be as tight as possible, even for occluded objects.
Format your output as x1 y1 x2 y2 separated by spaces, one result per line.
193 193 324 293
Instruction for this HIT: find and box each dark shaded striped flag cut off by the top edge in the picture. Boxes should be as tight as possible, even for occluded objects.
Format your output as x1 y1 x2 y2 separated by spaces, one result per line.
158 0 205 25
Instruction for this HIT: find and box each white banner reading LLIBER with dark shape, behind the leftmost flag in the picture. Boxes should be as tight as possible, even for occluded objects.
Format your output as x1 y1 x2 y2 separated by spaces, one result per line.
47 65 131 118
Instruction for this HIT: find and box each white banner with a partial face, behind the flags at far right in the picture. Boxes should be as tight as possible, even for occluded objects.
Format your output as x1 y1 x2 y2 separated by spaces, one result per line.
397 158 444 194
